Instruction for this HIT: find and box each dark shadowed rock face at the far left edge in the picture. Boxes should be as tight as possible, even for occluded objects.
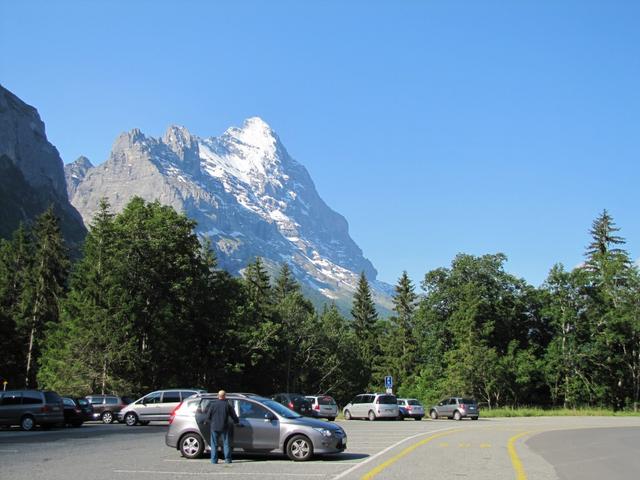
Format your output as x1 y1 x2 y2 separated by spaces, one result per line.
0 85 86 249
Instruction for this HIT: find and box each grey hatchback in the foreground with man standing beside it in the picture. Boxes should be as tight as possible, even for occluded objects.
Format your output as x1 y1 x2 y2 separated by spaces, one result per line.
165 394 347 461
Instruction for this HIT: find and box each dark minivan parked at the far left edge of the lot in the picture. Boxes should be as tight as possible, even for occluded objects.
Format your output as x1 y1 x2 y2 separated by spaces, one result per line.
0 390 64 431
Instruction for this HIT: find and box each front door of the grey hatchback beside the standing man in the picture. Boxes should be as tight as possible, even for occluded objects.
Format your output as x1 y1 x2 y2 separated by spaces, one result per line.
233 400 280 450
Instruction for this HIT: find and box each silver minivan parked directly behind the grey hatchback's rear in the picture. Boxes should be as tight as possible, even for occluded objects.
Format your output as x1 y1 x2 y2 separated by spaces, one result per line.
118 389 205 427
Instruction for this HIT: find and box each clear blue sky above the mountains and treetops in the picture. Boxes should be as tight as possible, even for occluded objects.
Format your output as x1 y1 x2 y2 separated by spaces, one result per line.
0 0 640 285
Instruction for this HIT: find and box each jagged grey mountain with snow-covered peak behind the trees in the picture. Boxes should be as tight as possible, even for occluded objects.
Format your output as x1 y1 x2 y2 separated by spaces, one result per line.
66 117 389 305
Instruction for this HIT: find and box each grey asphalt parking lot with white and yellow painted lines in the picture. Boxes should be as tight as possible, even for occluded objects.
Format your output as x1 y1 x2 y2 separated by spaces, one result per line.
0 417 640 480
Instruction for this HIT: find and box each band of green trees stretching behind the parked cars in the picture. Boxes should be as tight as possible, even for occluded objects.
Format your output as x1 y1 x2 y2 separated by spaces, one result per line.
0 198 640 410
